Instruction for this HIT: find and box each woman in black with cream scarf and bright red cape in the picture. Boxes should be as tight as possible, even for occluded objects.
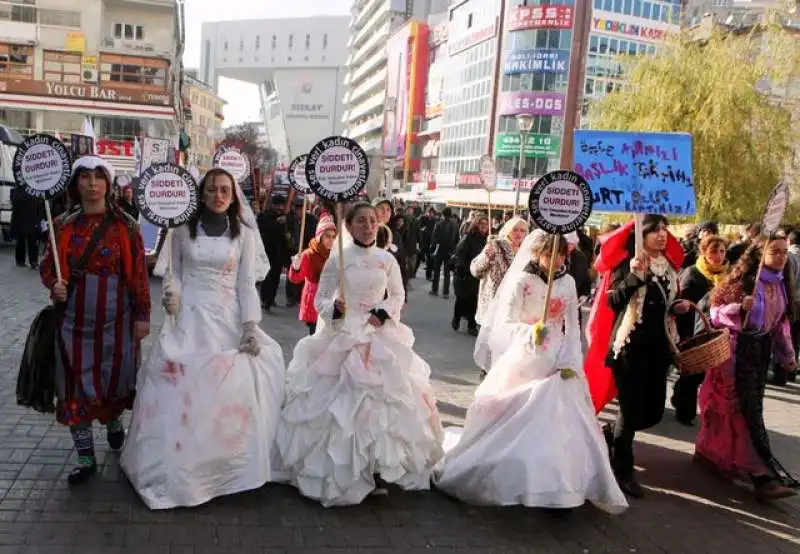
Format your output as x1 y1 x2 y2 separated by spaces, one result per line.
584 215 687 497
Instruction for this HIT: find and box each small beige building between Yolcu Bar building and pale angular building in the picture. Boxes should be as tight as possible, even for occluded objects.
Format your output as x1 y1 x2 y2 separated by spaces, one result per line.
183 71 227 172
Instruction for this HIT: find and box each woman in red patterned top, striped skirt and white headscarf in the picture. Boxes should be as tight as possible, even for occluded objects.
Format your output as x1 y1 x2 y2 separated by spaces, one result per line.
41 156 150 485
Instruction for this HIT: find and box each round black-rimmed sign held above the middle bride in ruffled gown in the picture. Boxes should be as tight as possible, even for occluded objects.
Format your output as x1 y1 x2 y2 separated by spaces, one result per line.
306 136 369 202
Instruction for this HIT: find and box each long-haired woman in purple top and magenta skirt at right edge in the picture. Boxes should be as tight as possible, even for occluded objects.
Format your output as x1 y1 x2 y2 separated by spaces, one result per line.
695 233 798 501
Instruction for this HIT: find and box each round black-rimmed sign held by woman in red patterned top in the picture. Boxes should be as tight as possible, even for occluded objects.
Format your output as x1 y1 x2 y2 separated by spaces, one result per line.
12 135 72 199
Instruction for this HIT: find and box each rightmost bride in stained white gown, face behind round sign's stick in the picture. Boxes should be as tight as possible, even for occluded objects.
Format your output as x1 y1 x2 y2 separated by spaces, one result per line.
434 231 627 513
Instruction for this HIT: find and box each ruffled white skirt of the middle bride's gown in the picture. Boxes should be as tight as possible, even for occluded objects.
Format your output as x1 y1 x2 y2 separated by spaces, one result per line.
273 316 443 507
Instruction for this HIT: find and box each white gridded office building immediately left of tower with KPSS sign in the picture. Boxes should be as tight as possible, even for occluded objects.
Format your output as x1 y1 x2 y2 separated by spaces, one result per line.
436 0 501 177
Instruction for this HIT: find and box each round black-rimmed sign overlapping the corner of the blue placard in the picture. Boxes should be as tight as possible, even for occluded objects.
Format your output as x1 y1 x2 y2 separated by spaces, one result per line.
528 171 592 235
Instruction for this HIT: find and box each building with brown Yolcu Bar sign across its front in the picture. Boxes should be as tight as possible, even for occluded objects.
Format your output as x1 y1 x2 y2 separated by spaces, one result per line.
0 0 177 171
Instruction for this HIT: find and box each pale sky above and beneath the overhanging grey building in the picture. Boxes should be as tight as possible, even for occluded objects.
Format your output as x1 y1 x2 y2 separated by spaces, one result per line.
183 0 351 126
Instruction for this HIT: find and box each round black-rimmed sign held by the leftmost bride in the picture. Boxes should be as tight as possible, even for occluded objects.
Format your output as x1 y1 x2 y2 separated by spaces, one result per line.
134 164 198 228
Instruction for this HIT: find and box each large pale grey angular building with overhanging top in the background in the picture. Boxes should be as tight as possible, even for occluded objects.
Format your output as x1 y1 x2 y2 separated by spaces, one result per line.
198 16 349 164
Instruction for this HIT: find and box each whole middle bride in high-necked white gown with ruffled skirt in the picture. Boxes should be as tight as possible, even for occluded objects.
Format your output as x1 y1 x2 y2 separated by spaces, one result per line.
273 203 442 507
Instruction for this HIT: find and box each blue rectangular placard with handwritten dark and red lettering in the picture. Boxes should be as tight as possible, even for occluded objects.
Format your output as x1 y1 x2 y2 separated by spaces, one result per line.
575 130 697 215
